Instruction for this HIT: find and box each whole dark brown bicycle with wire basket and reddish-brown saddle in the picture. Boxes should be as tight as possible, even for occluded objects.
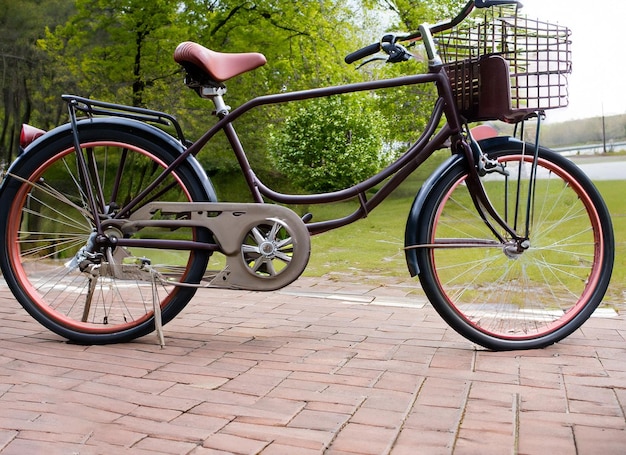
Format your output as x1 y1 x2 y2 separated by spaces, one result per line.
0 0 614 350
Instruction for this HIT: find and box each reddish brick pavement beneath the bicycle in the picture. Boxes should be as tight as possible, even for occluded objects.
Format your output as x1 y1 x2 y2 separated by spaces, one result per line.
0 278 626 455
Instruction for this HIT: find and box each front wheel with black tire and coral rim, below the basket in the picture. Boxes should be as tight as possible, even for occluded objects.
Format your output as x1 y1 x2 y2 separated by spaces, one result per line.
417 142 614 350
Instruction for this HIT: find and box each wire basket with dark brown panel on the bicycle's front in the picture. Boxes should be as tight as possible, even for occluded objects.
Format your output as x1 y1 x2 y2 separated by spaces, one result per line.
436 6 572 122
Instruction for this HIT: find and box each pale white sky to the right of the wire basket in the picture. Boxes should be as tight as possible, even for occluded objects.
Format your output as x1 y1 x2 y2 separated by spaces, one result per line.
521 0 626 123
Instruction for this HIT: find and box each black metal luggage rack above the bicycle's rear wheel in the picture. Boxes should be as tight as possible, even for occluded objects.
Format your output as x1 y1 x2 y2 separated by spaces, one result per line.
61 95 185 144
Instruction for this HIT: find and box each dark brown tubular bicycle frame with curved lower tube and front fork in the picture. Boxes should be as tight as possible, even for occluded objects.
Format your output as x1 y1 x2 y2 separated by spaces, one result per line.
70 68 522 246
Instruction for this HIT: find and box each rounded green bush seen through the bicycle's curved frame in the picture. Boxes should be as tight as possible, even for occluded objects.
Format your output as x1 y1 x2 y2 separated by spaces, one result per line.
270 96 387 192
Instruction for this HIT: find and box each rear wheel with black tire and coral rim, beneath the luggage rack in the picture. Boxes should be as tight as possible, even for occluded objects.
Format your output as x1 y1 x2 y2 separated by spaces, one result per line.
0 121 215 344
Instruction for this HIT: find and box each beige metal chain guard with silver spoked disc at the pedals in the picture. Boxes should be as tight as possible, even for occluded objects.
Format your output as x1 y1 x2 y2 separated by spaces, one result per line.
119 201 311 291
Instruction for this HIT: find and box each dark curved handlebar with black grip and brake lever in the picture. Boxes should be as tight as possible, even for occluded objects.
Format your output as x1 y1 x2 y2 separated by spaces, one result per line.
344 0 520 64
